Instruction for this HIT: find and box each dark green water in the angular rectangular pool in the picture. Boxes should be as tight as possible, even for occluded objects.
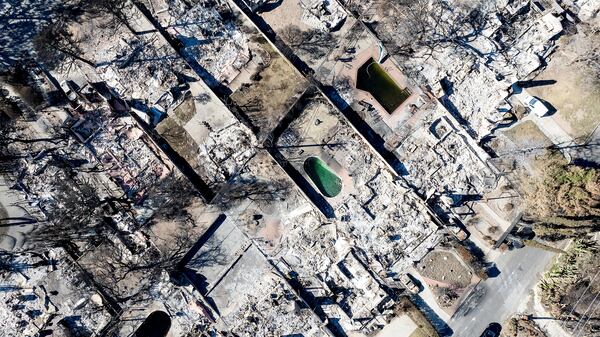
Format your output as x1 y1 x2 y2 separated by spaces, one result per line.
356 58 411 113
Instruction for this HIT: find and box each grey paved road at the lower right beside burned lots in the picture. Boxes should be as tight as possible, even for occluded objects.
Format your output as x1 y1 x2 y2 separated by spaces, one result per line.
448 247 554 337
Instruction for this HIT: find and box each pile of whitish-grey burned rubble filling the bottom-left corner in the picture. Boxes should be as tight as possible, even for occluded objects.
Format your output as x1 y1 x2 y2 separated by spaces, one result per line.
0 248 111 337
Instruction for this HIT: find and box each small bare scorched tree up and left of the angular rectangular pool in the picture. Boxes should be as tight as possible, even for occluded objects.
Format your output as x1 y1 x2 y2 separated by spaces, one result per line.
279 25 337 59
